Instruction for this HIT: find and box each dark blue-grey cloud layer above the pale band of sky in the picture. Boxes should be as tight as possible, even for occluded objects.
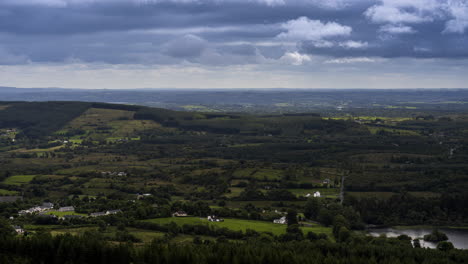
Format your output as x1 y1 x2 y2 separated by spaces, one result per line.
0 0 468 64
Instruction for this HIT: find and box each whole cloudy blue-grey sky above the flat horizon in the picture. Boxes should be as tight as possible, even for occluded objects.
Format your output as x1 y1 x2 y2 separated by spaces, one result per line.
0 0 468 89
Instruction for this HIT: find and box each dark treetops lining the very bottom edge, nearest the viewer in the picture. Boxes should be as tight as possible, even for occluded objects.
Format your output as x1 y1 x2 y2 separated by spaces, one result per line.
0 232 468 264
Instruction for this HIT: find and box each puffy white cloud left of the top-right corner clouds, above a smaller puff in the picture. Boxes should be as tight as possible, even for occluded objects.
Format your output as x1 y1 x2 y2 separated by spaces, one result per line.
277 17 352 41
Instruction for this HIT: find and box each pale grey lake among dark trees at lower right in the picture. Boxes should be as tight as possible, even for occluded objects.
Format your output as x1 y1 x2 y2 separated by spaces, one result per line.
368 227 468 249
